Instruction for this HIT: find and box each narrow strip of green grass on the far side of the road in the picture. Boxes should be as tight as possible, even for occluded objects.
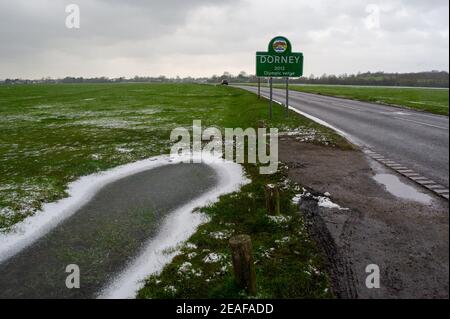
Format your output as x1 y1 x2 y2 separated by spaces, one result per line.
244 84 449 115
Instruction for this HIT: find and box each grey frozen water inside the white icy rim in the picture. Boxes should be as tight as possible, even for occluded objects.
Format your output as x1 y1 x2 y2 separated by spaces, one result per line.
0 164 218 299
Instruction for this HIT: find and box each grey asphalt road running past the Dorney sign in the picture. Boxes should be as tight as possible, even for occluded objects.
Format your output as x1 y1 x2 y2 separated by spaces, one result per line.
239 86 449 188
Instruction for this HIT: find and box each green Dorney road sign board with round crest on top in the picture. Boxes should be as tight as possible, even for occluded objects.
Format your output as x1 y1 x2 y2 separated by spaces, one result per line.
256 37 303 77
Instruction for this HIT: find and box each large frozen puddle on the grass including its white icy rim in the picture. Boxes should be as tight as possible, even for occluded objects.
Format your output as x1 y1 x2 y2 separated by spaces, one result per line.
0 157 247 298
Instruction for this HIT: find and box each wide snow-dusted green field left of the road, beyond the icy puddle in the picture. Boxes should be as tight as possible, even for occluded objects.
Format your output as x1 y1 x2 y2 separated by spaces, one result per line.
0 84 345 231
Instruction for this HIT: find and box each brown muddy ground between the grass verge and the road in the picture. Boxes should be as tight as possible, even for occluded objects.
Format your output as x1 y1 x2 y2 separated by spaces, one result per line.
279 137 449 298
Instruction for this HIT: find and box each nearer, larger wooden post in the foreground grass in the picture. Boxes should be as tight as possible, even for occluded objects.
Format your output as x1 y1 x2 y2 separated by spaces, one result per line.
229 235 256 296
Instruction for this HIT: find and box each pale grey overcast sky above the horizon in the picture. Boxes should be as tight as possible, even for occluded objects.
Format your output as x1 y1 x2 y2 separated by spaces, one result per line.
0 0 449 79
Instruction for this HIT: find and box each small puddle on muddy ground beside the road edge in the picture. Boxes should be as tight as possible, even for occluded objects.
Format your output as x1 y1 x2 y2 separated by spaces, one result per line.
373 174 431 204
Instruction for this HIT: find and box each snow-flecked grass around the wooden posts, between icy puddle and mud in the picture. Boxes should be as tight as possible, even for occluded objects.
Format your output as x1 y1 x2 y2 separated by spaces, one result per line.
138 165 333 299
